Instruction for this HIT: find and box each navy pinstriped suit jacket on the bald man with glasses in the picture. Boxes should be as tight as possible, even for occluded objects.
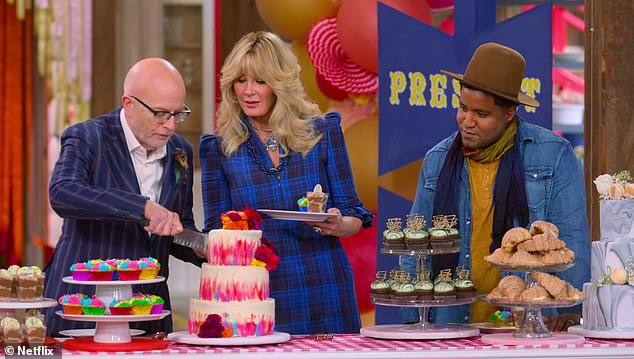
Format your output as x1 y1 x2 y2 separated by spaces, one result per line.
44 108 200 335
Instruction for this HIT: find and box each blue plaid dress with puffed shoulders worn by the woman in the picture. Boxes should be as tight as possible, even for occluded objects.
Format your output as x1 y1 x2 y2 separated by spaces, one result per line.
200 113 373 334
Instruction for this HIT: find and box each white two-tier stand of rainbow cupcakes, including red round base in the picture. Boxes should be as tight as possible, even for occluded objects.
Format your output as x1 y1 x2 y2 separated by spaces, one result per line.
55 276 170 351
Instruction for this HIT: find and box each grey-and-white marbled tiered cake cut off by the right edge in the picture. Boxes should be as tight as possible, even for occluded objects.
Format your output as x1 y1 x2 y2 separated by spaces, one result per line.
582 199 634 333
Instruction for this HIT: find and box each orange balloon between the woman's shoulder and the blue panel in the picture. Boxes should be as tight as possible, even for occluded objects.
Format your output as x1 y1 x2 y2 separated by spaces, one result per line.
343 114 379 213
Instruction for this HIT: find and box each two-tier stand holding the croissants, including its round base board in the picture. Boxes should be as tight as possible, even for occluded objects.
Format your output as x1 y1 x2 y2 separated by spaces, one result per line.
478 263 585 345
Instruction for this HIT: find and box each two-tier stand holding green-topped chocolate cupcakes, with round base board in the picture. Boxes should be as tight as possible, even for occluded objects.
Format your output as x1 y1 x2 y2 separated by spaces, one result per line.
361 247 480 339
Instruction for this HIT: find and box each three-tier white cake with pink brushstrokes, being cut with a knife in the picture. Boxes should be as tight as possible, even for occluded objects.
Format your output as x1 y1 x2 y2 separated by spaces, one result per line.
188 229 275 337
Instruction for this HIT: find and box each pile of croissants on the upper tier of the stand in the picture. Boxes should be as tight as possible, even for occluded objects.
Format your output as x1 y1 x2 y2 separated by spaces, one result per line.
484 221 575 268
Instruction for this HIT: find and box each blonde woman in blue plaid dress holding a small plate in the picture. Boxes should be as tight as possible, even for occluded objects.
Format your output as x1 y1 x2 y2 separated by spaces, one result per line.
200 31 373 334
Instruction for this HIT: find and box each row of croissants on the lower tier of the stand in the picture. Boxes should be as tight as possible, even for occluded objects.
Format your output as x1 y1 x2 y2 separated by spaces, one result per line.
487 272 583 302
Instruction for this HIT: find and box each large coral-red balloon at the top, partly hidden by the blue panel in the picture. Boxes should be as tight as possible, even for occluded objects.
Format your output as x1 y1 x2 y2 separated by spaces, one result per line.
337 0 432 74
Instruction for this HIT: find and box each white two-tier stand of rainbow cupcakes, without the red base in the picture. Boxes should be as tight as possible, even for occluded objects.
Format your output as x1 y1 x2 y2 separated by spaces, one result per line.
55 277 170 344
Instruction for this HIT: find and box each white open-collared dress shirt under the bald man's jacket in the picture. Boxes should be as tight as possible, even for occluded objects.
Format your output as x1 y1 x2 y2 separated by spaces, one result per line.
119 109 167 203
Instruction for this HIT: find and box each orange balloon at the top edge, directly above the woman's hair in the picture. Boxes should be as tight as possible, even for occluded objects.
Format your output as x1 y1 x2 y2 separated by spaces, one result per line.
255 0 338 41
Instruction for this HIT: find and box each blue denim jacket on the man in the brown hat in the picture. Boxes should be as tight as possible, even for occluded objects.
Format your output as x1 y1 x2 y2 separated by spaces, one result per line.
399 119 590 324
